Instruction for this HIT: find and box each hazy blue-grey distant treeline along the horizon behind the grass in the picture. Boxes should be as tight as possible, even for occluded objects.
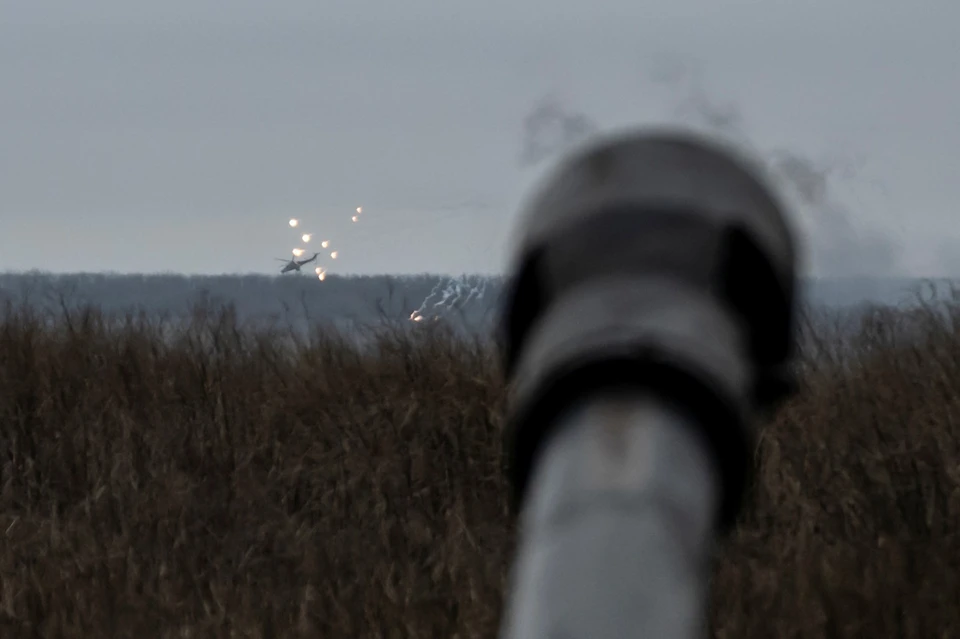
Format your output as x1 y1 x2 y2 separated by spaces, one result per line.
0 271 950 325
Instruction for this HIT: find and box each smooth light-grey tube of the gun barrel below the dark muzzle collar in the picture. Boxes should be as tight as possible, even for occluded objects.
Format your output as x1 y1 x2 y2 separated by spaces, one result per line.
501 388 720 639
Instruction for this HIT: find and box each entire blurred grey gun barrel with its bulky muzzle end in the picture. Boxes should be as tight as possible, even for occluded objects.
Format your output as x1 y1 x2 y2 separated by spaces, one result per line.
501 129 796 639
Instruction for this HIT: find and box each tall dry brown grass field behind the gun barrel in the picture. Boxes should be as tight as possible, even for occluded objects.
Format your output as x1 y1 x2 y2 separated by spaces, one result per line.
0 298 960 639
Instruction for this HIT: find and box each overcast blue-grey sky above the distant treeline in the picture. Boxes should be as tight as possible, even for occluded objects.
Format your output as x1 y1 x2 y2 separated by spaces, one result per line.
0 0 960 275
